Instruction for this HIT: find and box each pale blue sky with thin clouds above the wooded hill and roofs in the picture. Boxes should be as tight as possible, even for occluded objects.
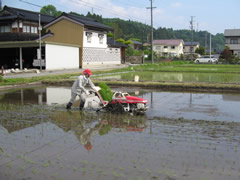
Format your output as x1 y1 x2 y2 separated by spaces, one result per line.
0 0 240 35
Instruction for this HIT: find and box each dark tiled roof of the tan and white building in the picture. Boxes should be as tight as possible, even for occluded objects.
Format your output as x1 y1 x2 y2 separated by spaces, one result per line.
55 13 114 31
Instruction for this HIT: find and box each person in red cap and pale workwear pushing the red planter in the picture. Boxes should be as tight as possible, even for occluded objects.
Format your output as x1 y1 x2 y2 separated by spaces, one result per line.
67 69 96 110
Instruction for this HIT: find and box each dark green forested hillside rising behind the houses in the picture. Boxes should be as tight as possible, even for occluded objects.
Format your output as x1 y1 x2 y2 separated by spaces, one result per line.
71 12 225 51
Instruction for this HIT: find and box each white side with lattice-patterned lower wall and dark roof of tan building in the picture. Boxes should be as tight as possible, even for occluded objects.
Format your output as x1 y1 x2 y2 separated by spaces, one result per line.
61 14 125 67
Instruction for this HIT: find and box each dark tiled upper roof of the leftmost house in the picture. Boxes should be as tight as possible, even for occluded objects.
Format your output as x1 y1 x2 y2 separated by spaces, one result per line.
0 6 56 24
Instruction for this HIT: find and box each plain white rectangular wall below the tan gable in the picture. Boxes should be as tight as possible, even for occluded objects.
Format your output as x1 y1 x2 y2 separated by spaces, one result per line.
45 44 79 70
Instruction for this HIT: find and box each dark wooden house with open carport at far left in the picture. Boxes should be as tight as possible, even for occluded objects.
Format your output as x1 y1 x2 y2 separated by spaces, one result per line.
0 6 55 68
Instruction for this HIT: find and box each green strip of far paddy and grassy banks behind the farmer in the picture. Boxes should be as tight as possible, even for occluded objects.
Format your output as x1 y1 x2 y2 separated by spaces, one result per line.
0 61 240 91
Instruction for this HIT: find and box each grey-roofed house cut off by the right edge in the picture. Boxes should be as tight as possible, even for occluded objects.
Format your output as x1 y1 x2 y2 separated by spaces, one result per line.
224 29 240 57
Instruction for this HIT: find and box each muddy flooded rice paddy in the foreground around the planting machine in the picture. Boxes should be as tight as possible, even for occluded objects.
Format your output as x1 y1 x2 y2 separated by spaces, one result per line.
0 87 240 180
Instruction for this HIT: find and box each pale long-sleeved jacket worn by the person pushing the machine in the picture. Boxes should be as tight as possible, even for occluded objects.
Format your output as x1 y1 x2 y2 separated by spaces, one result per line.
72 75 95 94
